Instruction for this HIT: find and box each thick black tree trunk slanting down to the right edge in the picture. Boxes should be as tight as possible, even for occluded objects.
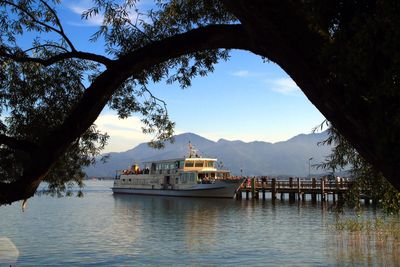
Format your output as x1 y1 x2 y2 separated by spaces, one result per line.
221 0 400 190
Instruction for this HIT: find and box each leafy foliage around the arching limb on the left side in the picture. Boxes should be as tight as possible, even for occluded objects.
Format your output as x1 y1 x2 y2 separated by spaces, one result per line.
0 0 235 201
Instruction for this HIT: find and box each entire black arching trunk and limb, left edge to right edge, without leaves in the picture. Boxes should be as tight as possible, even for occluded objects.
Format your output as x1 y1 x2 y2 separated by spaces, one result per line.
0 0 400 204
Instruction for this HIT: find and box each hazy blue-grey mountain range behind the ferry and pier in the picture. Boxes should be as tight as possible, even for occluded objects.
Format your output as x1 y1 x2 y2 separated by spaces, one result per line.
85 131 332 177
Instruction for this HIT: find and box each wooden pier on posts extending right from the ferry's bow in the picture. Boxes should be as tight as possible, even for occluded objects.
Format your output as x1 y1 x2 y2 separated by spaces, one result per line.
236 178 349 202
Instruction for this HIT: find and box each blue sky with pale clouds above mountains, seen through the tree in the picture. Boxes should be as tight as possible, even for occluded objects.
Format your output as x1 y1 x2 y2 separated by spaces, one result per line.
41 0 324 152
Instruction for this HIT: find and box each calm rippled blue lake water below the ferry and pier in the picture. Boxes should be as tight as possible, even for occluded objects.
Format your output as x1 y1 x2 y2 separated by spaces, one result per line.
0 181 400 266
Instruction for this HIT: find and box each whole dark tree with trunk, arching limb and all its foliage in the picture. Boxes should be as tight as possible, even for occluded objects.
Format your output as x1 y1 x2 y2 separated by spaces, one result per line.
0 0 400 204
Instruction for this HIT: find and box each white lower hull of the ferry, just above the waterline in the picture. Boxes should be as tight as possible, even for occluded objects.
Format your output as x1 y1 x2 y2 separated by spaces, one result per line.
112 180 242 198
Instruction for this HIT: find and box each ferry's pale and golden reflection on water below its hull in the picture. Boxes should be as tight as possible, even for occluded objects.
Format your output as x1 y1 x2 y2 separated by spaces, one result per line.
113 195 236 253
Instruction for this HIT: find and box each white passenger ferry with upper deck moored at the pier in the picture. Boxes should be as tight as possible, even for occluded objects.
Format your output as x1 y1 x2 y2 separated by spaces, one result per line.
112 144 243 198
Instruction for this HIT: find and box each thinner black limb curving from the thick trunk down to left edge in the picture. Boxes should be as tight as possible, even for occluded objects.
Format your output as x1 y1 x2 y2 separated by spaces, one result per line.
0 25 250 205
